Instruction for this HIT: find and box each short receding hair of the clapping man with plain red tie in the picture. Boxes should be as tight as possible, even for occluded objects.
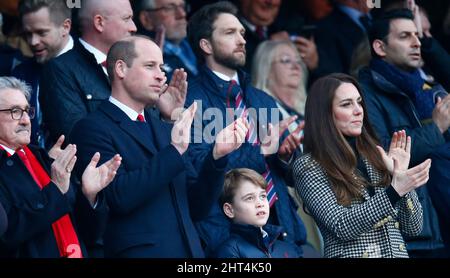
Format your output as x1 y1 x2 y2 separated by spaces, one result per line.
106 35 153 82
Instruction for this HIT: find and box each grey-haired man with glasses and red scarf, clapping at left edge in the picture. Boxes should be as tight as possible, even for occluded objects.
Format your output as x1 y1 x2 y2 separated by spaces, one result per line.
0 77 120 258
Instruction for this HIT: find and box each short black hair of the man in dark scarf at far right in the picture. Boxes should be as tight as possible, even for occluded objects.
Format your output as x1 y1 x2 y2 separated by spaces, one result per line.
369 9 414 57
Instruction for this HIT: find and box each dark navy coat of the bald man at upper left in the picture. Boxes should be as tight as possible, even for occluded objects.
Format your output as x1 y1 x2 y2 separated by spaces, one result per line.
39 40 111 146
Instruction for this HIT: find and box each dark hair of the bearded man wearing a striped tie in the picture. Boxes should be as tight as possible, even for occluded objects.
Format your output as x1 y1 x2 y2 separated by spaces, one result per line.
187 1 238 63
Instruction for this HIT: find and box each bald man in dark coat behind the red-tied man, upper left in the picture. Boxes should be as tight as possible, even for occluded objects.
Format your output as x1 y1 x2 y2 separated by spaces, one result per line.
40 0 136 142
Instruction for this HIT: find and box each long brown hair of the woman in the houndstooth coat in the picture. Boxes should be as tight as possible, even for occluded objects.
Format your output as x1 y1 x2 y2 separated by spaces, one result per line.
303 73 391 206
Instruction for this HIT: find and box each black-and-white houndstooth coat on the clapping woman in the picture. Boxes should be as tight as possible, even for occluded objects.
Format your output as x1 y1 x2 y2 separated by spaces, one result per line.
293 154 423 258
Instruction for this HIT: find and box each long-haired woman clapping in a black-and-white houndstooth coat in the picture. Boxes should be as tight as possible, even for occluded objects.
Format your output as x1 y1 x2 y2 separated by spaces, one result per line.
293 74 431 258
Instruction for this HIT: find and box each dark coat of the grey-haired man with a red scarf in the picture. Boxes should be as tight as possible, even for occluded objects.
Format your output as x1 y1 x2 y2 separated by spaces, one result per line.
0 147 107 258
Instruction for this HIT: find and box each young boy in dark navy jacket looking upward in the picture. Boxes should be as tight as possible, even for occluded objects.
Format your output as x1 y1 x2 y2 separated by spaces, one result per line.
216 168 301 258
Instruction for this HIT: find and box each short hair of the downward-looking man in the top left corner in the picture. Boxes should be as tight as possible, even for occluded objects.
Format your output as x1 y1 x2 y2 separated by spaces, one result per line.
19 0 72 25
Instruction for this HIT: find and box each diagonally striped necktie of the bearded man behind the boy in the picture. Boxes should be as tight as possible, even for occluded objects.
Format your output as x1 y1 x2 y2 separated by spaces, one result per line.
227 80 278 207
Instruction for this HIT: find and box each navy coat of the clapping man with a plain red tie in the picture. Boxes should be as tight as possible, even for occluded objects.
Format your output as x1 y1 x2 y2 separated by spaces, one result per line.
71 101 227 258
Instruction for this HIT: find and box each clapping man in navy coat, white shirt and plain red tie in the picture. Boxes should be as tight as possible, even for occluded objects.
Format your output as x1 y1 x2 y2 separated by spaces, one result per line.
71 36 247 258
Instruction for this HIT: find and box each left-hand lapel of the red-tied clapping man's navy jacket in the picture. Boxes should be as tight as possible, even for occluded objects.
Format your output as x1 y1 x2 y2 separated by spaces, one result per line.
99 101 157 154
